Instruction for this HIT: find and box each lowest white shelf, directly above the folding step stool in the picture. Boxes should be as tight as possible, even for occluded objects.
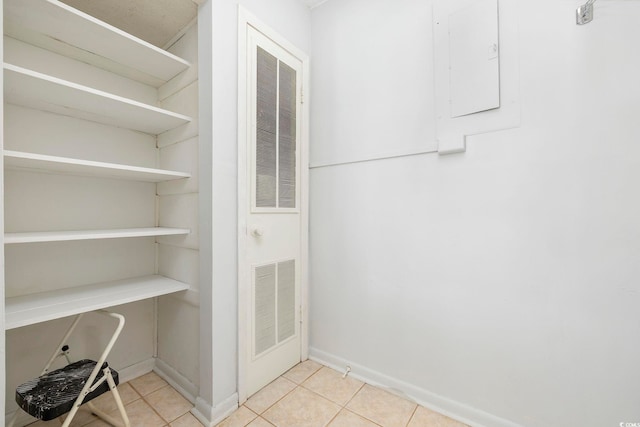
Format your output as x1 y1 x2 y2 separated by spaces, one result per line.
5 276 189 329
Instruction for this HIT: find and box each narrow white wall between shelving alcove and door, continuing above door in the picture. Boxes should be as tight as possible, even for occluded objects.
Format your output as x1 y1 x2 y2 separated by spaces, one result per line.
197 0 311 417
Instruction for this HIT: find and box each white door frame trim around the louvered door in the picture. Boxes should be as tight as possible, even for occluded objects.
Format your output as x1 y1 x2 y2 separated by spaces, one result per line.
238 5 310 404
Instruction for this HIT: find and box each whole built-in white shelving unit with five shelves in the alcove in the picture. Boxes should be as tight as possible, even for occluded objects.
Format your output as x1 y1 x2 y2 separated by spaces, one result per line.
2 0 192 338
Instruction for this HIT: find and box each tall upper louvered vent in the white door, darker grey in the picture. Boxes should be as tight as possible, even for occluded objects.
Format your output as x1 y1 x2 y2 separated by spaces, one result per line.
255 47 298 209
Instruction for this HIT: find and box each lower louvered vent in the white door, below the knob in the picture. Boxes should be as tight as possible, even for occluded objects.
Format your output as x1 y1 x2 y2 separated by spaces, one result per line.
253 260 296 356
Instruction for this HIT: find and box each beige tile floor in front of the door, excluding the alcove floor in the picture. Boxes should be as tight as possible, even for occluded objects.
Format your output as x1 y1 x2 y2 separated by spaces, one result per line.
217 360 467 427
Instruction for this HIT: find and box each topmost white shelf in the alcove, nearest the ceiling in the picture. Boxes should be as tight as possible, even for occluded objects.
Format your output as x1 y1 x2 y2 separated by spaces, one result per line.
4 0 190 87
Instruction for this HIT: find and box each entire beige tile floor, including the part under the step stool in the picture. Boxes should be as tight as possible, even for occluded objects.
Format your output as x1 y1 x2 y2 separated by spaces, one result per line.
29 360 466 427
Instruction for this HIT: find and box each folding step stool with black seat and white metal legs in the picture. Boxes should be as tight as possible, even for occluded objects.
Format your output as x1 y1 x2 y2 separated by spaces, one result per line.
7 310 130 427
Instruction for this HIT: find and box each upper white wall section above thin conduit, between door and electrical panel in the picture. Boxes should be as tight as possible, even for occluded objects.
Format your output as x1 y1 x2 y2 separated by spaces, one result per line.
310 0 435 166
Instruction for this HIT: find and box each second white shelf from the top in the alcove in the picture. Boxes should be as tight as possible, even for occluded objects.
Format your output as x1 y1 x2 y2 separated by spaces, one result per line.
4 63 192 135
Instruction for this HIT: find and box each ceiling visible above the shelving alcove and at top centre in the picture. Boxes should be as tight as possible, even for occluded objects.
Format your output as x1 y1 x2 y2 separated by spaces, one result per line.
60 0 327 47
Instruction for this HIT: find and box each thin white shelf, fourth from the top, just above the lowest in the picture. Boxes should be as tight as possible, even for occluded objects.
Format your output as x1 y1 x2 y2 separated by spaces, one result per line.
4 227 191 244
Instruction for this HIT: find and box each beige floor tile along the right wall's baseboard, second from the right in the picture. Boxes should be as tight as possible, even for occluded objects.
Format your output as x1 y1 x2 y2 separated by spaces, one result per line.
346 384 418 427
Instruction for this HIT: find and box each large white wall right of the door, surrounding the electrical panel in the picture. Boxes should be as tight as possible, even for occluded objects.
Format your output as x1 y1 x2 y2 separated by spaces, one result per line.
310 0 640 427
